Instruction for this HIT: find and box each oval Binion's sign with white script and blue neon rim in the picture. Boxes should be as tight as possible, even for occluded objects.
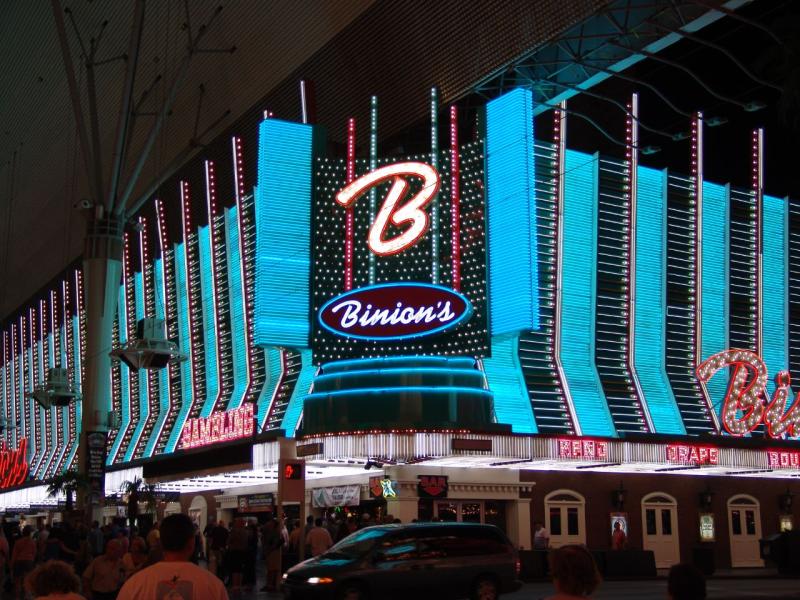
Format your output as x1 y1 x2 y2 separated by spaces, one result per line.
319 283 472 341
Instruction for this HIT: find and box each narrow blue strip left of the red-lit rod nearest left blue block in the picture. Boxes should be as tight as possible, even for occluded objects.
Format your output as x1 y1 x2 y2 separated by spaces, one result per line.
225 206 248 410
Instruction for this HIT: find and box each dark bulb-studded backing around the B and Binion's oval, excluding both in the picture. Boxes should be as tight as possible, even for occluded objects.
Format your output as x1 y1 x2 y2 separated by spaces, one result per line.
311 141 489 364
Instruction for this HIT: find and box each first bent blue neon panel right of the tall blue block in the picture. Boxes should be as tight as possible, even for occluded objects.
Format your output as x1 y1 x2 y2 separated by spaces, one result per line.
560 150 617 436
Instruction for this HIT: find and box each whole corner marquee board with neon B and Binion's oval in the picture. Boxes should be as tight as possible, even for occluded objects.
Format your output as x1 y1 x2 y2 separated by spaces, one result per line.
311 146 489 363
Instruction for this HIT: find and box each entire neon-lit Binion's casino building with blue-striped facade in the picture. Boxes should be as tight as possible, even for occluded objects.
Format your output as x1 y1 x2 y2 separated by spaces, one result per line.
0 0 800 567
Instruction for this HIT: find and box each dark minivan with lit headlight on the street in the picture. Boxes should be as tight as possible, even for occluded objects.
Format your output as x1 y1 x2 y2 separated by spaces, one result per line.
282 523 521 600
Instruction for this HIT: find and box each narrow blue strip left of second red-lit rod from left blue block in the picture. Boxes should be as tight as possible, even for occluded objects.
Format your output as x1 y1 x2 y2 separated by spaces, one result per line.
197 227 220 417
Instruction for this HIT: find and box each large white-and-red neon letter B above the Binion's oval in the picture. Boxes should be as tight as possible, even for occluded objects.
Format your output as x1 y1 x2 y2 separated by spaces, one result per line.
336 162 441 256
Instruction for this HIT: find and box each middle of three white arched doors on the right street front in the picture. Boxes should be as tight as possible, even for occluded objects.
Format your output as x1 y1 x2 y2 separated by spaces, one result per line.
642 492 681 569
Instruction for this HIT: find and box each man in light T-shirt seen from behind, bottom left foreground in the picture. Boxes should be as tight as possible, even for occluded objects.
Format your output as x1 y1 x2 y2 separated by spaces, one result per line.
117 514 228 600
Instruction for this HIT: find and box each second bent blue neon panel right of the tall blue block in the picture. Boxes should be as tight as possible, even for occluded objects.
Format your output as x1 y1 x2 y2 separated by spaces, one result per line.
634 167 686 434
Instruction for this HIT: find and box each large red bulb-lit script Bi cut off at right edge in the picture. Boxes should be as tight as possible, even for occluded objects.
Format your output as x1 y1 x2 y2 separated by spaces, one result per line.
697 349 800 438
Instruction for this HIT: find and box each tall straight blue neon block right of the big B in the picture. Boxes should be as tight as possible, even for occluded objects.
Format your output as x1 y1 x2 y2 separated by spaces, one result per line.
486 88 539 336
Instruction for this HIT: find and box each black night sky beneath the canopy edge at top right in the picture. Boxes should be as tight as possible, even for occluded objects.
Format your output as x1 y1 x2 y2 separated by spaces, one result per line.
556 0 800 197
